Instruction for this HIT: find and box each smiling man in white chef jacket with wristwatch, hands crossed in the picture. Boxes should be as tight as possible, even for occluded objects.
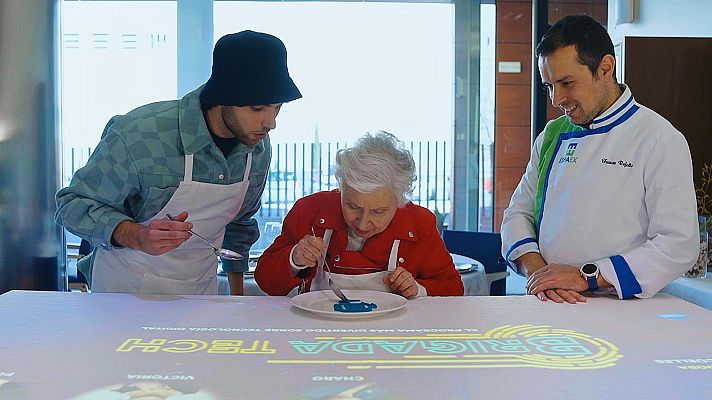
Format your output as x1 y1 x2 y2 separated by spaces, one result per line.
501 15 699 303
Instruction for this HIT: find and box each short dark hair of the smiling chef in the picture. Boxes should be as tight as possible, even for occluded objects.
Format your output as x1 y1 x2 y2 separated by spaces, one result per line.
536 15 615 75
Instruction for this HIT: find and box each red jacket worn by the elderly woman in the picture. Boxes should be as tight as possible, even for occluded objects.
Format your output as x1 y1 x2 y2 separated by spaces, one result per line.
255 190 464 296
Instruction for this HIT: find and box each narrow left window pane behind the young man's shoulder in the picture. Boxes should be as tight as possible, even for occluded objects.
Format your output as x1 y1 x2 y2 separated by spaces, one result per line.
60 1 177 247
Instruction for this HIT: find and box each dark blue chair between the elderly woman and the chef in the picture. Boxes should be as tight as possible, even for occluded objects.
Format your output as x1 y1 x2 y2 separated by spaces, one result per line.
443 230 509 296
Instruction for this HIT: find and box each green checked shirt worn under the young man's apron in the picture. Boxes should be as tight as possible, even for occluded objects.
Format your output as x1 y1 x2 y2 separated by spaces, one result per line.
55 87 272 272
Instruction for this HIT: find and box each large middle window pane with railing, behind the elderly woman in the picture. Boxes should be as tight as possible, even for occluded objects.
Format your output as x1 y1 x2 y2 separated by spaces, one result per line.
214 1 455 249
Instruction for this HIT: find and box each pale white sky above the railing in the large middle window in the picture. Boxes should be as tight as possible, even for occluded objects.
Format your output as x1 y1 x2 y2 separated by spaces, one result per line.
214 2 454 145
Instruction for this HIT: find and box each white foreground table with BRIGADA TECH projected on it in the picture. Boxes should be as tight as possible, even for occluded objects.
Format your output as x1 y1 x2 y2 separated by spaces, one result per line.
0 291 712 400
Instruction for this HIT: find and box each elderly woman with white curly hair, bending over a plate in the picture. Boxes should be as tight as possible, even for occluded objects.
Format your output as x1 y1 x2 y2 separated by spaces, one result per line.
255 131 463 298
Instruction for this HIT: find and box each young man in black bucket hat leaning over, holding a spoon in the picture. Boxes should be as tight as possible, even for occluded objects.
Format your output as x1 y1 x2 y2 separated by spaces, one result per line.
55 31 302 294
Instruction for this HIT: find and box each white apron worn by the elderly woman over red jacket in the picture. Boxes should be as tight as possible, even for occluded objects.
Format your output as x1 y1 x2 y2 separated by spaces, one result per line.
310 229 400 292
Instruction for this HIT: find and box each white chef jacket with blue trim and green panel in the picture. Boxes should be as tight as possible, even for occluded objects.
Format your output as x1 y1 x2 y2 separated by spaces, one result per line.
501 88 699 299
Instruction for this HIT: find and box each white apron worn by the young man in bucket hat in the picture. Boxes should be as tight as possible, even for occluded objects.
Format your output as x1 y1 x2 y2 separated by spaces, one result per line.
91 152 252 294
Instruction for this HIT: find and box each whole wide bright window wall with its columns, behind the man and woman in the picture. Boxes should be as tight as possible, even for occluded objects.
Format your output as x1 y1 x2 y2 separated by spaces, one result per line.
61 0 495 256
